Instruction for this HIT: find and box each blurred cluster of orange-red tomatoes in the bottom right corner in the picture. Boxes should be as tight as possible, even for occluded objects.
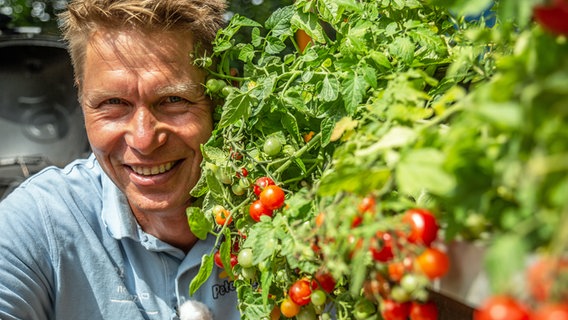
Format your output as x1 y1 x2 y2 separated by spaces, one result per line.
474 257 568 320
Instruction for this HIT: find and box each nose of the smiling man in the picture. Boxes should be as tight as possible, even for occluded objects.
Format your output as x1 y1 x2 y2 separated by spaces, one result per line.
125 107 166 154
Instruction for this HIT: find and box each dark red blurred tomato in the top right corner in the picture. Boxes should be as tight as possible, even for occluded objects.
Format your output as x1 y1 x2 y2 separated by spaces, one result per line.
533 0 568 35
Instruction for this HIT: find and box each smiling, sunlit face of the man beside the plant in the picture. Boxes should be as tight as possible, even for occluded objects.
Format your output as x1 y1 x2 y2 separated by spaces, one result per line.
79 31 213 216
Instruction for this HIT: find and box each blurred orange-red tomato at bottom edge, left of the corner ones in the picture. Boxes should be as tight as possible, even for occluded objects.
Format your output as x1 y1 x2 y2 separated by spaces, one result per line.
473 295 529 320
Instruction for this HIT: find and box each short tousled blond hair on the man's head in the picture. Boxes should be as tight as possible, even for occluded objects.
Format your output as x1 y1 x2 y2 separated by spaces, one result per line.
59 0 226 81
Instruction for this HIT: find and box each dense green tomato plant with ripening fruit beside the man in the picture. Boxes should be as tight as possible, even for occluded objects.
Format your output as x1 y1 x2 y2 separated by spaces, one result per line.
187 0 568 320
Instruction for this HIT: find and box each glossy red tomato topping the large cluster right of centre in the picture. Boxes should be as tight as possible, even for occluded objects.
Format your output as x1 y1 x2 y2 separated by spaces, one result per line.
402 209 439 246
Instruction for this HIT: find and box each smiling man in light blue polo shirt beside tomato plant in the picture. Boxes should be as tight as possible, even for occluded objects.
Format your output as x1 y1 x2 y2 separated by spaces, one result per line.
0 0 239 320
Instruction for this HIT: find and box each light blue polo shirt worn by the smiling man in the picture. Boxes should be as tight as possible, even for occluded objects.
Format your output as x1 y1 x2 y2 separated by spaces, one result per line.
0 155 240 320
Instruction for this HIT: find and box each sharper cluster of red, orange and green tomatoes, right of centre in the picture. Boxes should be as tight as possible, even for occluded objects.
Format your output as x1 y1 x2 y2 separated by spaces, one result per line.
352 201 450 320
